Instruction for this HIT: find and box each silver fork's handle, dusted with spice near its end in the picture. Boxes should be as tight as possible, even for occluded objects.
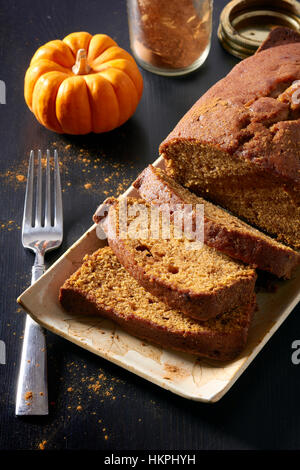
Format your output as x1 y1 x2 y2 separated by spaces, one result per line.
16 263 48 416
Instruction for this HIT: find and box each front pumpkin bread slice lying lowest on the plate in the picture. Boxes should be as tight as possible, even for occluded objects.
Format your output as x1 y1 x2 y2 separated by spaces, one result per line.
59 247 255 361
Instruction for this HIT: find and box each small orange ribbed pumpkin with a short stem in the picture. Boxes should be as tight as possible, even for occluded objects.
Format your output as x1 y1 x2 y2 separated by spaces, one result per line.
24 32 143 134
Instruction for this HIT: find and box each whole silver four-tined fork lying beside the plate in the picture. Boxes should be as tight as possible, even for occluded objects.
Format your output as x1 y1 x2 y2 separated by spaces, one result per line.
16 150 63 416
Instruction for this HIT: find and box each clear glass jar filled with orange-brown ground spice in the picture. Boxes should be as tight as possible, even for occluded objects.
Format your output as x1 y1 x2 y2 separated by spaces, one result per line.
127 0 213 76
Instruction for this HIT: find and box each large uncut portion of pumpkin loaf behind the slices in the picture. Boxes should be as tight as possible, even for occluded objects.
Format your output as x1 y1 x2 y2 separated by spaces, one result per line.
160 28 300 248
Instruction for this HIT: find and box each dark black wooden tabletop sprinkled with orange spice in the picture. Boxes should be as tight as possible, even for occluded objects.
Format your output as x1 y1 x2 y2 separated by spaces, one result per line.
0 0 300 451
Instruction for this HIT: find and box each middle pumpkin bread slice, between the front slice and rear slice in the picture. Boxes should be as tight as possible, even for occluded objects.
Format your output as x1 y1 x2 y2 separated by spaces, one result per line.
98 198 256 320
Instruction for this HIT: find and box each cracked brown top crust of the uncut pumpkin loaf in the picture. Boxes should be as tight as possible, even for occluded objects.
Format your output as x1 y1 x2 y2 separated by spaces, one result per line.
159 28 300 187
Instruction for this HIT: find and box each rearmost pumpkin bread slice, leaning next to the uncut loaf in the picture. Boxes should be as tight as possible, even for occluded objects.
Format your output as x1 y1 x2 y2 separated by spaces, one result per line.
133 165 300 279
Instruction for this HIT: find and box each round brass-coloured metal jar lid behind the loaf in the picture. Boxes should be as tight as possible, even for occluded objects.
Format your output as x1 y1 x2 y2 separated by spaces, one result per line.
218 0 300 59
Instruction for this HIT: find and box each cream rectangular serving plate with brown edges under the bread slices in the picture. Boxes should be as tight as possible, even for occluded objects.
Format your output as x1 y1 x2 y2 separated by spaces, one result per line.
18 157 300 402
